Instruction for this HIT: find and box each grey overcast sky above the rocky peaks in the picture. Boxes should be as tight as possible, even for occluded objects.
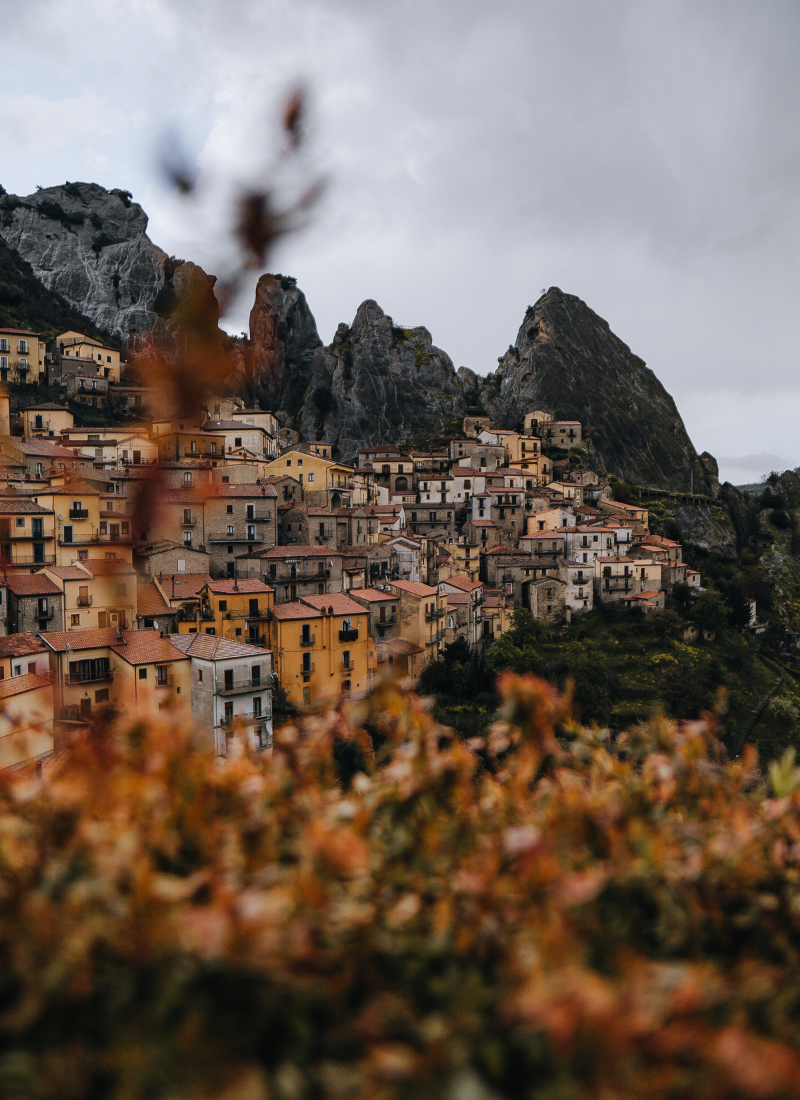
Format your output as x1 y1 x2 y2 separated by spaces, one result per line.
0 0 800 482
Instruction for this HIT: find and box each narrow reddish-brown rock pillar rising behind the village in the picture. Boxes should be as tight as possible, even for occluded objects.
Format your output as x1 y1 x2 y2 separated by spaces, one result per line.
244 275 322 417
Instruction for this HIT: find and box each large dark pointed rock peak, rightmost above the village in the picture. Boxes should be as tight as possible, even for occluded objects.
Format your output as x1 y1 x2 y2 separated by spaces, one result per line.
481 287 719 492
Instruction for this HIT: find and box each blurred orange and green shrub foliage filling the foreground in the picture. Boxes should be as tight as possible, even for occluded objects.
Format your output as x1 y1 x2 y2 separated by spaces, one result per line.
0 673 800 1100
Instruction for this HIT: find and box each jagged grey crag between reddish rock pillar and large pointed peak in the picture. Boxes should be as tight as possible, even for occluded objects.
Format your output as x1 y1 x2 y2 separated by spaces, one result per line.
300 300 475 462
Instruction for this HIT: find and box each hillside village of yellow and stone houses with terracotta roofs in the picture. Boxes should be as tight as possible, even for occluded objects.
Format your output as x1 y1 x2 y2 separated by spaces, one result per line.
0 319 701 767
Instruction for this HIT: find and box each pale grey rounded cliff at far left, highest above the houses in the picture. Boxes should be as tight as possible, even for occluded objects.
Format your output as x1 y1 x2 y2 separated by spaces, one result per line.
0 184 168 341
